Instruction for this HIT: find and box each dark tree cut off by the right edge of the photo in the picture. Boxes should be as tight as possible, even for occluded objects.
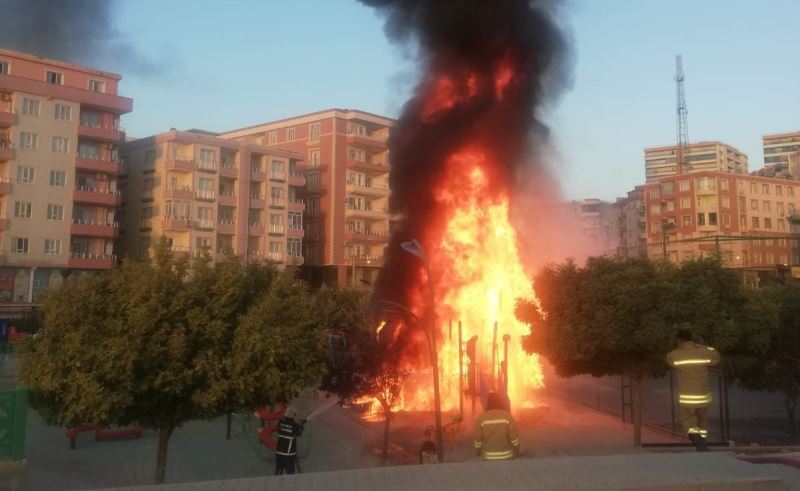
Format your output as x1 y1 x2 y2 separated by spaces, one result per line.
731 283 800 443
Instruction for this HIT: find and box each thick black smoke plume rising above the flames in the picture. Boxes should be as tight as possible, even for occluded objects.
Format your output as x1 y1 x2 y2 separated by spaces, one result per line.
361 0 569 324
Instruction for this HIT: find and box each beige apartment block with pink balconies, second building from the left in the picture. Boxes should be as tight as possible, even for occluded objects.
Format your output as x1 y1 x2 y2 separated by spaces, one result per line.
120 130 306 264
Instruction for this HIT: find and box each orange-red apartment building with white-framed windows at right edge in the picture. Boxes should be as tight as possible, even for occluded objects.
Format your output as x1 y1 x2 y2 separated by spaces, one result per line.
644 172 800 286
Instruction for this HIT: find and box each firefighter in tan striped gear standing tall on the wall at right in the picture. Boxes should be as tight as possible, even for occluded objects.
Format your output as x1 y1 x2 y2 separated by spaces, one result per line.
667 329 720 452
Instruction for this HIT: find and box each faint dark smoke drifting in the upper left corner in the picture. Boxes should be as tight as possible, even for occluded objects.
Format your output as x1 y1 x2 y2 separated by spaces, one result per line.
0 0 163 76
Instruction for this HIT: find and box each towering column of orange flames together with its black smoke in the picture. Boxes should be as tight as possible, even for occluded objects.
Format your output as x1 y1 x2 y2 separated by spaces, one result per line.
362 0 566 410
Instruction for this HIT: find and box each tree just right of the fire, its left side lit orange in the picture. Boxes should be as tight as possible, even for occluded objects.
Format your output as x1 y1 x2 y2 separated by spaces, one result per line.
516 257 743 446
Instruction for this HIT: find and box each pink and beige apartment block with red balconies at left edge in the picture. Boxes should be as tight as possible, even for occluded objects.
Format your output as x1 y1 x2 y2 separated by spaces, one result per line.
0 49 133 304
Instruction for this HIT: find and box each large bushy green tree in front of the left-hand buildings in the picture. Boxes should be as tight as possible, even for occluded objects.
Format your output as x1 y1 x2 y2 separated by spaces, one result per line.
21 241 322 483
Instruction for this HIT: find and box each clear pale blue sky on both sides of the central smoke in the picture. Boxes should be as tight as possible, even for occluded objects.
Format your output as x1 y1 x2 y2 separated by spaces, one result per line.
112 0 800 200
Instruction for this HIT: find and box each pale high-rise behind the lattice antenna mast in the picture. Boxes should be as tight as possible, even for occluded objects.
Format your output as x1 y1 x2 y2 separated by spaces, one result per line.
644 141 747 184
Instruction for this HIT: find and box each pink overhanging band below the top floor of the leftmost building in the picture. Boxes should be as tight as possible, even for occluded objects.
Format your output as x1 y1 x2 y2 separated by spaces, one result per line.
0 75 133 114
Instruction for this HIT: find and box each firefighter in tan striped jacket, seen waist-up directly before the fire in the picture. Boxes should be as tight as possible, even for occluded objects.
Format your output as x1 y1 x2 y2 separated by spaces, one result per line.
475 392 519 460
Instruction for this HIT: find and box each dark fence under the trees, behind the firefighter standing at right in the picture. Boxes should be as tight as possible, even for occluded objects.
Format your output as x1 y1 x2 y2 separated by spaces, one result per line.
547 374 796 445
